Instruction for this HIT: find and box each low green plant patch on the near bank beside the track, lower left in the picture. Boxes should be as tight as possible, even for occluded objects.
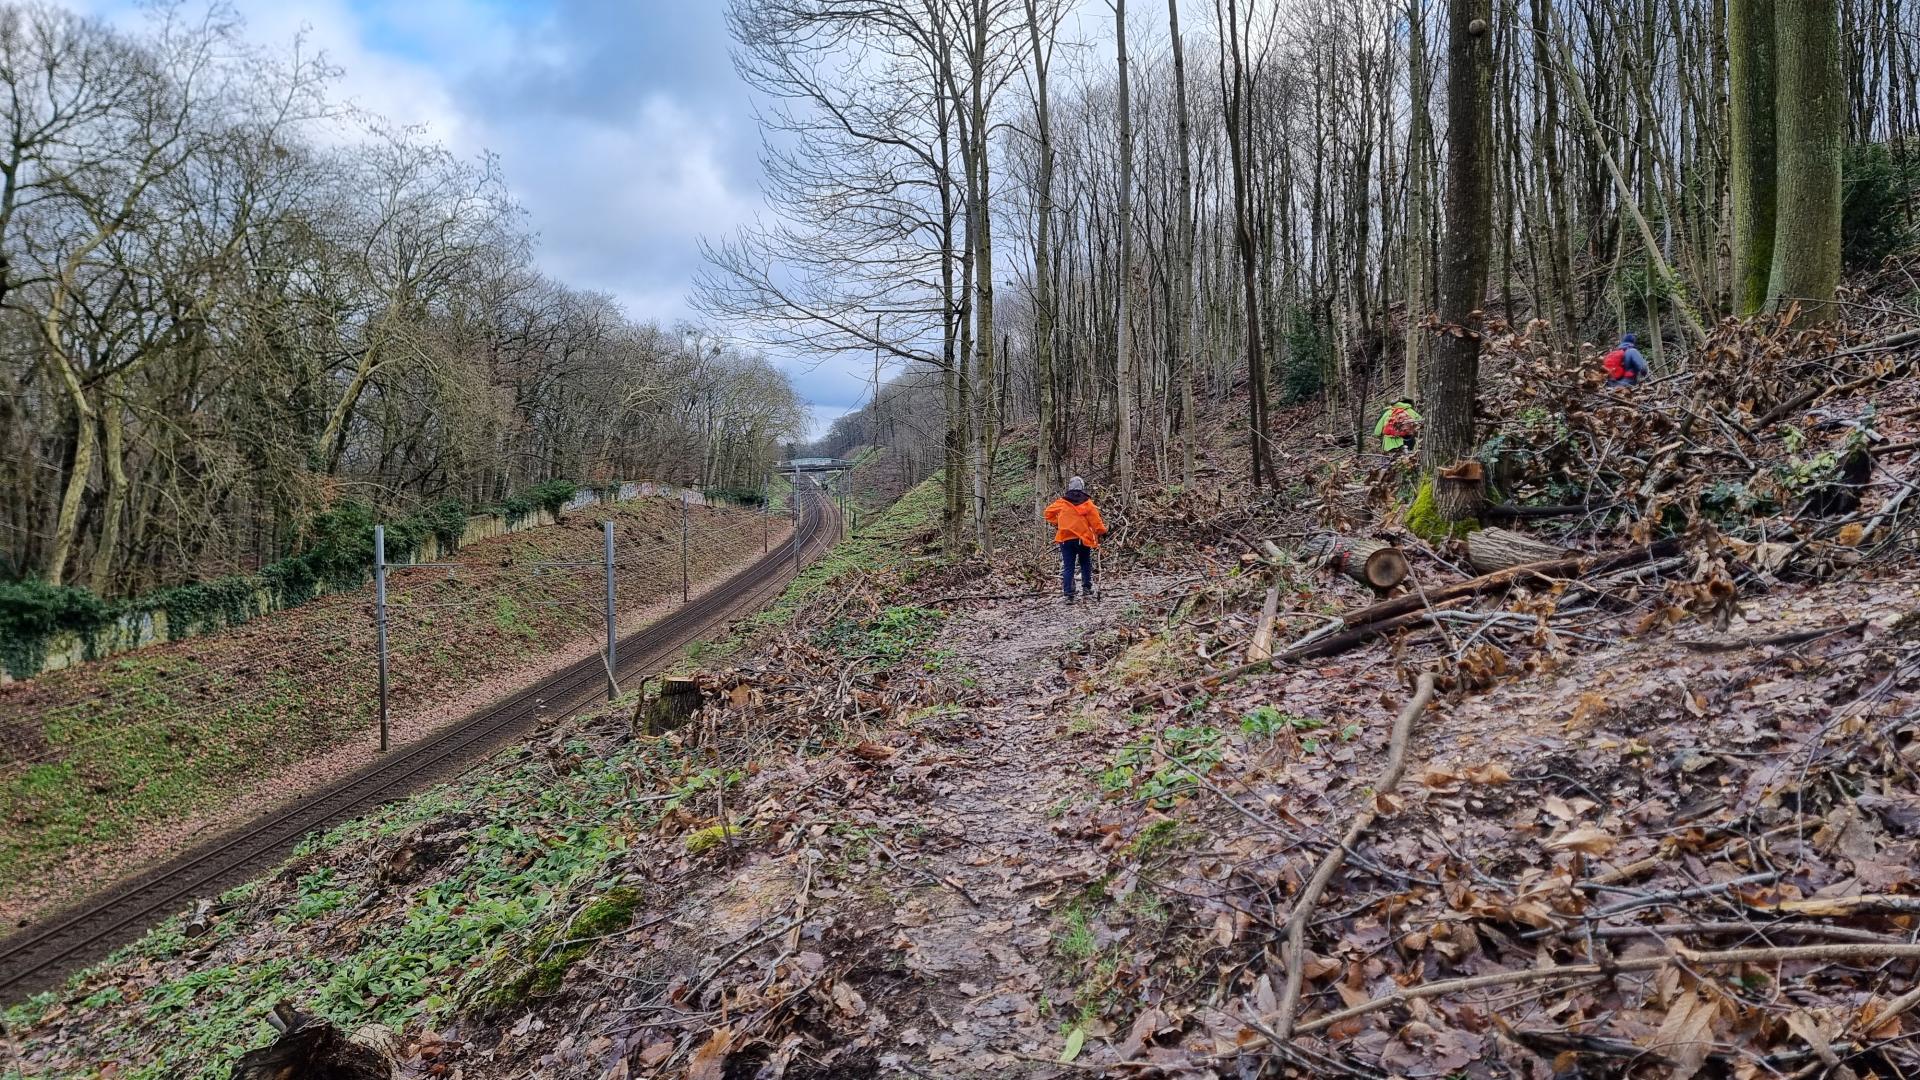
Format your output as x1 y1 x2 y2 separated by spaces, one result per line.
0 722 699 1080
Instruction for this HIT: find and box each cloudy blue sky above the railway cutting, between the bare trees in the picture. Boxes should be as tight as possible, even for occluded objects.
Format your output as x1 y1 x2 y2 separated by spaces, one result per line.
69 0 879 430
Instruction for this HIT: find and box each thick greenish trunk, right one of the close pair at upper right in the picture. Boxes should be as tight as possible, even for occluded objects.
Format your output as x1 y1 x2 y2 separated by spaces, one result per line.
1766 0 1847 323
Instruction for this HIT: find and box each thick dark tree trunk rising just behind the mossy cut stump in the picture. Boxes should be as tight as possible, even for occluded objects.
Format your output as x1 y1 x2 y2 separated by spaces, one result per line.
1421 0 1492 474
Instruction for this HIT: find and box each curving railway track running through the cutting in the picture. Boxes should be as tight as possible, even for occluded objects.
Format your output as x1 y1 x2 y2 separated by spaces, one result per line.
0 478 839 1003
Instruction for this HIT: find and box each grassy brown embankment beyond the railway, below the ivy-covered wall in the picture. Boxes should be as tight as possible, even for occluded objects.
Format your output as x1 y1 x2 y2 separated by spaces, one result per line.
0 500 787 926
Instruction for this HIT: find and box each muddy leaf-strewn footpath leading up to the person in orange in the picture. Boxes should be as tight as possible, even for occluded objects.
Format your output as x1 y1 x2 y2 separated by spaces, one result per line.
848 578 1165 1078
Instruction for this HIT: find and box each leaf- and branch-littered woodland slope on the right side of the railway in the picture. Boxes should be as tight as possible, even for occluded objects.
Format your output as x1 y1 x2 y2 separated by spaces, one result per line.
0 320 1920 1080
